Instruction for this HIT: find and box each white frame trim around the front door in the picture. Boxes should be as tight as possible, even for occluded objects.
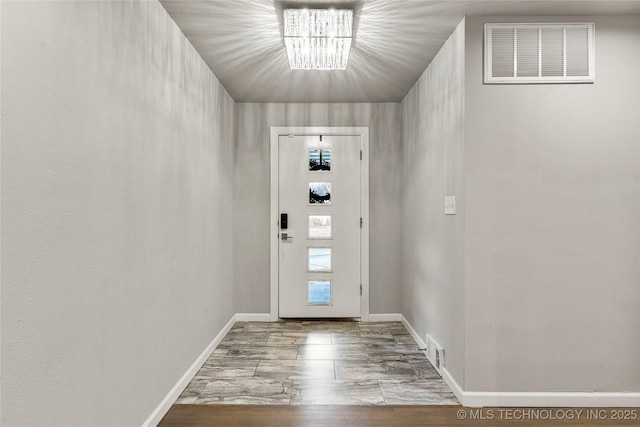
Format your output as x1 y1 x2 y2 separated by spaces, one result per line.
269 127 369 322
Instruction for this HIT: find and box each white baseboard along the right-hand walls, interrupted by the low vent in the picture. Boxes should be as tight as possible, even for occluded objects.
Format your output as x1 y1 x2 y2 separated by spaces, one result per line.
401 315 640 408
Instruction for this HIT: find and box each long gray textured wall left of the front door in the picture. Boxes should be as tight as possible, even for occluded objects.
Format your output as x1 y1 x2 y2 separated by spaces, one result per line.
1 2 235 426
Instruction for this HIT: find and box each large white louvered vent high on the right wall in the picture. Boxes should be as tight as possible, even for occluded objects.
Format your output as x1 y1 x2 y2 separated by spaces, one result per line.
484 23 595 83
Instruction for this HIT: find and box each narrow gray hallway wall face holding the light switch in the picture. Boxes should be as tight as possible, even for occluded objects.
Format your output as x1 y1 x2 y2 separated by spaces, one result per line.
402 22 465 385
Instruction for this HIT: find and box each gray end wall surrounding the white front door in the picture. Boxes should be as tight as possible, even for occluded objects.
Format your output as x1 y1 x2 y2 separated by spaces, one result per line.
233 103 402 313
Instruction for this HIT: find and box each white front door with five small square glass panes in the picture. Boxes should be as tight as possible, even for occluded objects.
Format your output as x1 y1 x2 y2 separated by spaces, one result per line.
278 135 362 318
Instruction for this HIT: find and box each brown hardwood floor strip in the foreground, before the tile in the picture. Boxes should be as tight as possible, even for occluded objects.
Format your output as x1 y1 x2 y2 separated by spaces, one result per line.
160 405 640 427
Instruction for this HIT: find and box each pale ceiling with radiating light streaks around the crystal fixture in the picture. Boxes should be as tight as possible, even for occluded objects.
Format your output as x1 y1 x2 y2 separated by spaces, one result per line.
160 0 640 102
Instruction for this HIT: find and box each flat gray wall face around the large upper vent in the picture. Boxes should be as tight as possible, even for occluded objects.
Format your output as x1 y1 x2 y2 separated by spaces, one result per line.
465 16 640 392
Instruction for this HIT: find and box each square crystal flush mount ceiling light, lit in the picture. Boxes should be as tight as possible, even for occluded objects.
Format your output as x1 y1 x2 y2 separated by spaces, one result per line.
284 9 353 70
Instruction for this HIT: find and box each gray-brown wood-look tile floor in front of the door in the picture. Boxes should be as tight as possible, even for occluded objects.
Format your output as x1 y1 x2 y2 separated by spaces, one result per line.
176 320 459 405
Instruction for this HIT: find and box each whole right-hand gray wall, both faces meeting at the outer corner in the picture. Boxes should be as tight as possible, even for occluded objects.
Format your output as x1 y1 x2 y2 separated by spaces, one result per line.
402 16 640 402
